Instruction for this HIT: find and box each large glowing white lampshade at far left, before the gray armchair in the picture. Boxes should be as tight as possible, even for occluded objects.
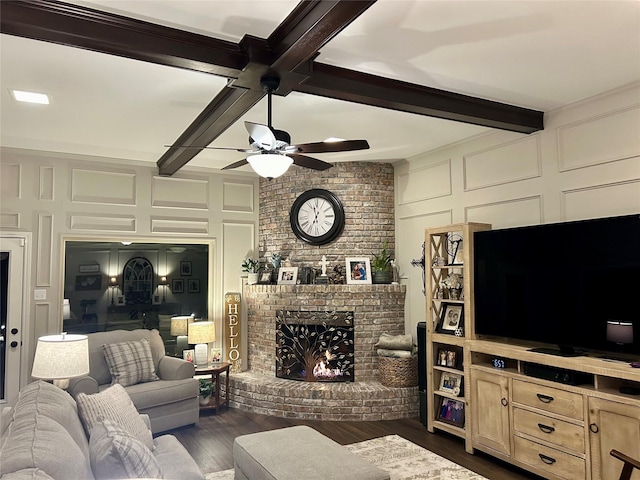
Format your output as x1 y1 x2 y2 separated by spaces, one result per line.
31 333 89 380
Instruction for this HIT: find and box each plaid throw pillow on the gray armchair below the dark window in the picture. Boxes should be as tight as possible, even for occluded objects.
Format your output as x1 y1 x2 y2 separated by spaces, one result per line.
102 338 159 387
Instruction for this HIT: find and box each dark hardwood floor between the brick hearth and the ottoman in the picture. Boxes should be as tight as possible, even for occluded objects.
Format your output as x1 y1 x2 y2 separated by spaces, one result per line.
168 408 540 480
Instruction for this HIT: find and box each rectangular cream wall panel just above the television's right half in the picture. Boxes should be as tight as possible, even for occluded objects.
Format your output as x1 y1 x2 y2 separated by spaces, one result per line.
562 179 640 221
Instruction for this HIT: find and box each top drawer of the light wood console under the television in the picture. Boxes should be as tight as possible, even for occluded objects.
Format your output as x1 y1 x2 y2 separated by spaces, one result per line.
512 380 584 420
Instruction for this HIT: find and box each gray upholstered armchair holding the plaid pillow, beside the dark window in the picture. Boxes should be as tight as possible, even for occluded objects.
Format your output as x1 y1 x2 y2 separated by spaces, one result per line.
68 329 200 433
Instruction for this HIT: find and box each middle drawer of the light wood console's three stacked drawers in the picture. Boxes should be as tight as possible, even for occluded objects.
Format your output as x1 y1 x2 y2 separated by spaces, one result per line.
513 407 585 453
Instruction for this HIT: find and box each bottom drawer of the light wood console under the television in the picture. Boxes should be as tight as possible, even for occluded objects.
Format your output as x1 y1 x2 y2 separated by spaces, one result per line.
513 435 586 480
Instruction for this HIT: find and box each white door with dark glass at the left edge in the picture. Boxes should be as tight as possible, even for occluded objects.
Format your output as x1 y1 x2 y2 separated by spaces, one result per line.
0 233 28 408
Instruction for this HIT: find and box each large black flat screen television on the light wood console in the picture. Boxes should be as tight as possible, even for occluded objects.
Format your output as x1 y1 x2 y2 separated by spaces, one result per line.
473 215 640 358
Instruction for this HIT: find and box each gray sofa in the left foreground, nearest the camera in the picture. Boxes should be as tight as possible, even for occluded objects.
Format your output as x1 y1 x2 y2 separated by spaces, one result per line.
0 381 204 480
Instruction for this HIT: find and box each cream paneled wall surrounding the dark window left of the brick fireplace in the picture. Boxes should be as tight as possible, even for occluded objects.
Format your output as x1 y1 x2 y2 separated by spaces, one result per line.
0 148 258 382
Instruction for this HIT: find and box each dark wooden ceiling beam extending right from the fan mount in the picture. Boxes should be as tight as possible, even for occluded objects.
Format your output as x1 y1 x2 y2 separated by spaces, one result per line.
293 62 544 133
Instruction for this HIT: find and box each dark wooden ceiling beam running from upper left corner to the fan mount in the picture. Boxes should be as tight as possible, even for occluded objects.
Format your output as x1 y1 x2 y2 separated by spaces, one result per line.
0 0 249 77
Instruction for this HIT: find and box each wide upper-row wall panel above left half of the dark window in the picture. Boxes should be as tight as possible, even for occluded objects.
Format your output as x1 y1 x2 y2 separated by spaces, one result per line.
71 168 136 205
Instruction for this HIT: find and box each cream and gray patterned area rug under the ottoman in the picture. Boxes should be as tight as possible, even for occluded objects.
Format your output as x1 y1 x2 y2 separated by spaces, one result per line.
206 435 487 480
